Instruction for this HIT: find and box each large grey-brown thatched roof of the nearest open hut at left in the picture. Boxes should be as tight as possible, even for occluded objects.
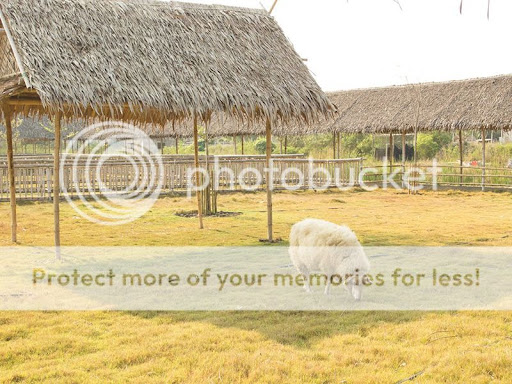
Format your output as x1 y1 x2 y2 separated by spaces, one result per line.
0 0 332 123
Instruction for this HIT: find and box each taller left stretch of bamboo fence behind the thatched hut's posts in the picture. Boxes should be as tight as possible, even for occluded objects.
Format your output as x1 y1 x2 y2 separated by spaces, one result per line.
0 156 363 201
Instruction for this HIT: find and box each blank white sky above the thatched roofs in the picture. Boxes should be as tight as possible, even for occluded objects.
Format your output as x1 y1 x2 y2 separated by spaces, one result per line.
188 0 512 91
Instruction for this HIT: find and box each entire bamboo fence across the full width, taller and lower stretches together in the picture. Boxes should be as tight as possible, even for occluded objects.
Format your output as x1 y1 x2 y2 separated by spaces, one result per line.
0 155 512 201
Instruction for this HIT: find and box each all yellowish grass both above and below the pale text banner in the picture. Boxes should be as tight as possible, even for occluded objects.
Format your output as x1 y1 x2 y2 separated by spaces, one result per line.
0 191 512 383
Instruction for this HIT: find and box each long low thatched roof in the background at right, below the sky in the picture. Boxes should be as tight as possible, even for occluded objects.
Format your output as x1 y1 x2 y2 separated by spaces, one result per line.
326 75 512 133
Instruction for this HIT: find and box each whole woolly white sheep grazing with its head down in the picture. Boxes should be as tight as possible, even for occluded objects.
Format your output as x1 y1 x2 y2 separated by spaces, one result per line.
289 219 370 301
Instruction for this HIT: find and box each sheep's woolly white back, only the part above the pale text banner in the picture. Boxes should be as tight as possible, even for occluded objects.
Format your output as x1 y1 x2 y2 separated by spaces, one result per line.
290 219 360 247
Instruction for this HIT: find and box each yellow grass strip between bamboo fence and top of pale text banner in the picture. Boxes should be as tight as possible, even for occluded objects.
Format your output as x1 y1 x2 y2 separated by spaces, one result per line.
0 191 512 246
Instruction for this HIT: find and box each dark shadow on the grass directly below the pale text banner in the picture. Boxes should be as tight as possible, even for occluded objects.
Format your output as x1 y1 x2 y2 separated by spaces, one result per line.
129 311 425 348
